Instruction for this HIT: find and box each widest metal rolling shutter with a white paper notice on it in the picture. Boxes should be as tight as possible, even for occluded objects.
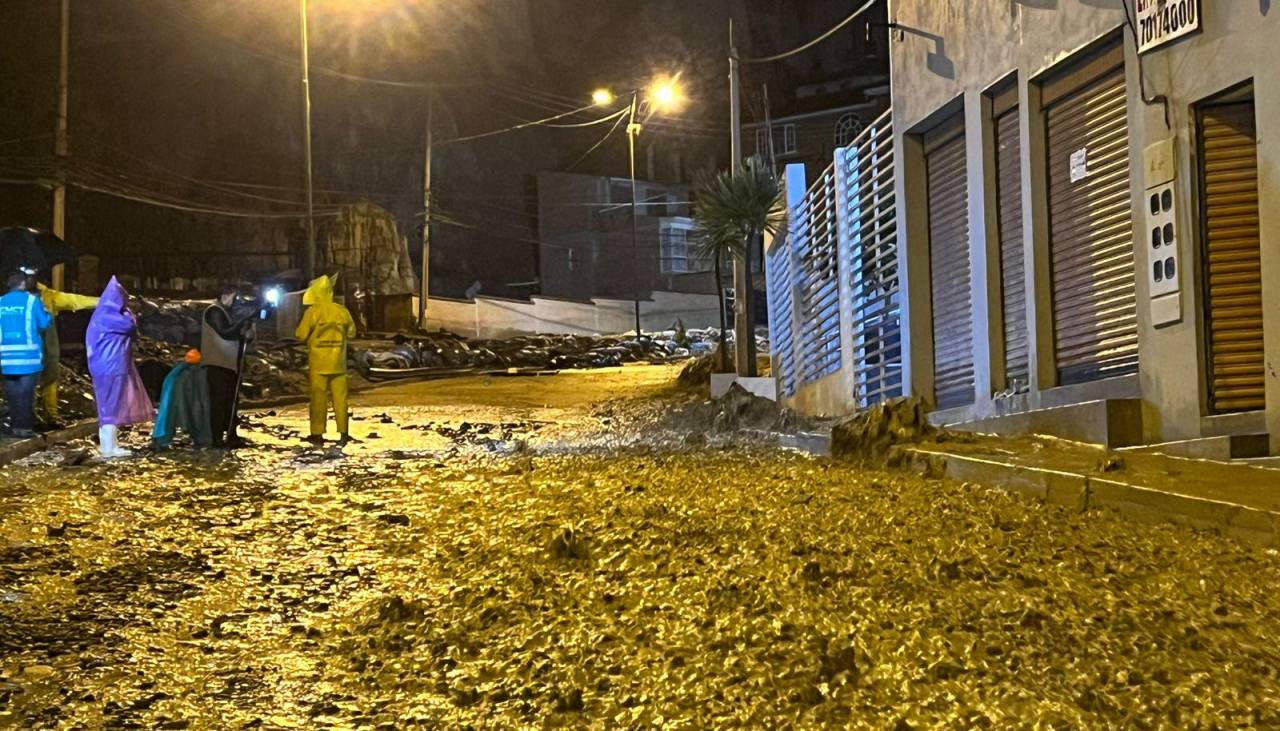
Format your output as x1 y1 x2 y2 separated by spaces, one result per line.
1046 67 1138 384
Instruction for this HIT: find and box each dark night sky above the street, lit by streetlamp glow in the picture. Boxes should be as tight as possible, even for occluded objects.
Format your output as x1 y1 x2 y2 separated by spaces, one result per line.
0 0 880 294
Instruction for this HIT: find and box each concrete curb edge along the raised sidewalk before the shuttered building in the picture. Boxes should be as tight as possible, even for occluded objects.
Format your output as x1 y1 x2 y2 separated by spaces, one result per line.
901 447 1280 547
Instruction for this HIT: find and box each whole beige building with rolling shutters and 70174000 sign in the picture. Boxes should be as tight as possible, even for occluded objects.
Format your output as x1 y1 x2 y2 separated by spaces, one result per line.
890 0 1280 453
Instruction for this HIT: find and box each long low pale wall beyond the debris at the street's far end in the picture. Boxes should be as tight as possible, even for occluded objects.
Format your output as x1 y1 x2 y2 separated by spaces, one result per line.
426 292 719 338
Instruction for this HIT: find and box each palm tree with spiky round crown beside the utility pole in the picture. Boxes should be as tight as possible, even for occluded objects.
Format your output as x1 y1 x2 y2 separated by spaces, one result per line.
694 156 787 376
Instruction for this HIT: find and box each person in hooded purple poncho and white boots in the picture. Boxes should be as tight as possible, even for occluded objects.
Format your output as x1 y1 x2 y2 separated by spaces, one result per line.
84 277 155 457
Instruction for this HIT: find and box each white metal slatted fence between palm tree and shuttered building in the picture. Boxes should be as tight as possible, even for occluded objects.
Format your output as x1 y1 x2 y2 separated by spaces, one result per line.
765 113 902 408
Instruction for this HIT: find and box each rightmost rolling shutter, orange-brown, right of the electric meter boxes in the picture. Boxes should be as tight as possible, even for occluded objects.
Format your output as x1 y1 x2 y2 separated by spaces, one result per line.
1201 101 1266 414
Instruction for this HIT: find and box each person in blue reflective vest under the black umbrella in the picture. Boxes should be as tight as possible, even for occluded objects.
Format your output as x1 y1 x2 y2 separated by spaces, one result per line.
0 270 54 439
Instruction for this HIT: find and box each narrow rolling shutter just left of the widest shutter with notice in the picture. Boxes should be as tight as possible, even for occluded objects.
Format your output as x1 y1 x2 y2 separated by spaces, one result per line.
996 106 1029 387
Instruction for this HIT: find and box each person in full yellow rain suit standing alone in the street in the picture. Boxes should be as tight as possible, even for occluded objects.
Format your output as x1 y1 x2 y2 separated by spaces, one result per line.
296 277 356 444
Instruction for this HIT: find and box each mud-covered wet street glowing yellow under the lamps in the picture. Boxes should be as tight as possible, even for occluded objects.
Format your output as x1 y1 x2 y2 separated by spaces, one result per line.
0 367 1280 728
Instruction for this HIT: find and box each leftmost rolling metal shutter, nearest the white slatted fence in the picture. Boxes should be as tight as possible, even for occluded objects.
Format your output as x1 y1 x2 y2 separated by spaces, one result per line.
925 131 974 408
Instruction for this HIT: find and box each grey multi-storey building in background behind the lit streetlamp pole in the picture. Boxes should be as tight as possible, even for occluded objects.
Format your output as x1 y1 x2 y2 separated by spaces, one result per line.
538 173 716 301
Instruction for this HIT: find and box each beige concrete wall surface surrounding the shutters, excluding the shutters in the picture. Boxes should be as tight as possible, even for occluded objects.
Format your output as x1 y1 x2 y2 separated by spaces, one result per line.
891 0 1280 448
